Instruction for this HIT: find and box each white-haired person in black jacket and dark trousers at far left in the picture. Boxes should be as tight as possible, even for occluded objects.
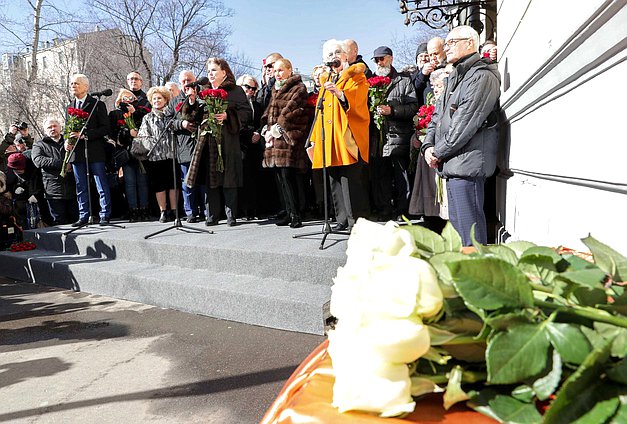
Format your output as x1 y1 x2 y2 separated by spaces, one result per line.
32 118 76 225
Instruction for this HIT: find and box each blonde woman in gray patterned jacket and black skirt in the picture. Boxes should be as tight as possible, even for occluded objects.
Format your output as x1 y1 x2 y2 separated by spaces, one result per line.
131 87 180 222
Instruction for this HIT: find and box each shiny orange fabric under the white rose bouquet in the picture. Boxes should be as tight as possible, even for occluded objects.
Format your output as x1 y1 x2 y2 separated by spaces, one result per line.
261 340 495 424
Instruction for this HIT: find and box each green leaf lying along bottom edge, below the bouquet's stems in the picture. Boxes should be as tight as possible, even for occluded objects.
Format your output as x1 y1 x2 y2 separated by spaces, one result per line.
469 389 542 424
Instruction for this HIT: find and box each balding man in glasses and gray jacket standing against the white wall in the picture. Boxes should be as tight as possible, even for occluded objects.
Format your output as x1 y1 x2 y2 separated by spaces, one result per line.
421 26 501 246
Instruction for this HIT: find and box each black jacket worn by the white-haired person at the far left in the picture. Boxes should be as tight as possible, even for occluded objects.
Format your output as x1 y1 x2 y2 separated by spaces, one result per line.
32 137 76 199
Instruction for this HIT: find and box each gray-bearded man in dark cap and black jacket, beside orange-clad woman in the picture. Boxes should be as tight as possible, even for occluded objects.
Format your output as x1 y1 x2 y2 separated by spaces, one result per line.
370 46 418 220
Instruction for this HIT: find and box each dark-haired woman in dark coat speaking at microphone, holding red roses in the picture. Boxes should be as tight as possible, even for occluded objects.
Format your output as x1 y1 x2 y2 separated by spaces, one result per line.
186 57 252 227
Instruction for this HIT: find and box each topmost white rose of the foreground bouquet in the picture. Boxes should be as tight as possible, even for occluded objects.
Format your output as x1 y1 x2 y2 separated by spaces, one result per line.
346 218 417 266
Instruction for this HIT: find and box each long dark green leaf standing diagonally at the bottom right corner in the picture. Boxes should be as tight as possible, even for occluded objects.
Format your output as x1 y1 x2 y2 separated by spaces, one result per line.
544 341 610 424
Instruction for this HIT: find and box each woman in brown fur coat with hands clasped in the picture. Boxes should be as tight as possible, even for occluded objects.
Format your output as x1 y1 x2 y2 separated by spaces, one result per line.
261 59 309 228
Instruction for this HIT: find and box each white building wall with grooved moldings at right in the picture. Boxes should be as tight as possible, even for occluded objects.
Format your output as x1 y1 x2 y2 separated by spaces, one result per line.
497 0 627 255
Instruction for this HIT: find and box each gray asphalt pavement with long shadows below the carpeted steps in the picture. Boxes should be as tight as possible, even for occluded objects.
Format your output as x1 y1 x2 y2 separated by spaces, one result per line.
0 278 324 424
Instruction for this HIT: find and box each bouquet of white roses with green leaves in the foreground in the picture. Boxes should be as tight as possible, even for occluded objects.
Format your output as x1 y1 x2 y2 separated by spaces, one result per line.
328 219 627 423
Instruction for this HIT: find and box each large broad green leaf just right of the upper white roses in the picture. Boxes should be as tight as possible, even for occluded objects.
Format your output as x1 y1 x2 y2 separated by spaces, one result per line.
448 258 533 310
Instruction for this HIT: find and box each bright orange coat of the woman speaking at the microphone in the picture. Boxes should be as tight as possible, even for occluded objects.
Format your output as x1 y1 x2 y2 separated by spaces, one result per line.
311 63 370 169
